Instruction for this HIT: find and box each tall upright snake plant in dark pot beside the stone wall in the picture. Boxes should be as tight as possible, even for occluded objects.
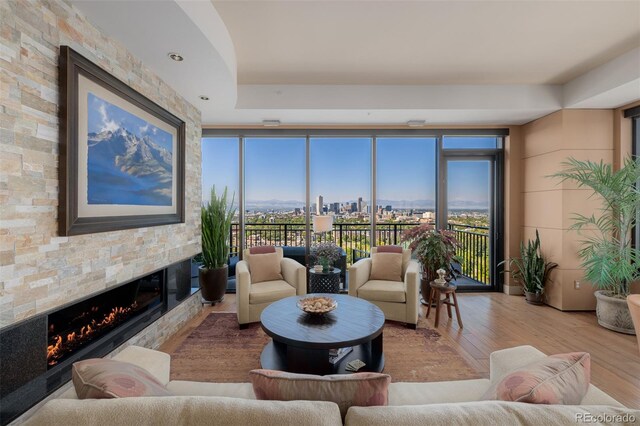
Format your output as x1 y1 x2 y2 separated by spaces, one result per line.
198 186 235 303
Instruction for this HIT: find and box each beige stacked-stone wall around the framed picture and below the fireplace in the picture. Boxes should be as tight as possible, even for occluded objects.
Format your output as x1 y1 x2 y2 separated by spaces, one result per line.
0 0 201 328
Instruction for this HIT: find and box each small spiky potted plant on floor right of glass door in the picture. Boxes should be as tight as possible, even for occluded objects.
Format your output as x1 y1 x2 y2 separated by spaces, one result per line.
498 229 558 305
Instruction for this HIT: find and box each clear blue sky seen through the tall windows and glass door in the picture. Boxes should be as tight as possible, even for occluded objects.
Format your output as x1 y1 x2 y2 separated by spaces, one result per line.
202 137 496 208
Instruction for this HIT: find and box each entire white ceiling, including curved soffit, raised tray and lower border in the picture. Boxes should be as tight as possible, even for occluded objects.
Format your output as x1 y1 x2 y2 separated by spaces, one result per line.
72 0 640 126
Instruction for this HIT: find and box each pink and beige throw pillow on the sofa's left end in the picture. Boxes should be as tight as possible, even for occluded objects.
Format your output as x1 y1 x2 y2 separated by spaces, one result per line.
71 358 171 399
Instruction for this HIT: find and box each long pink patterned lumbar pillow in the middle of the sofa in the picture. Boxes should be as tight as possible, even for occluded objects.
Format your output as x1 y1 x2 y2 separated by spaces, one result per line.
250 370 391 418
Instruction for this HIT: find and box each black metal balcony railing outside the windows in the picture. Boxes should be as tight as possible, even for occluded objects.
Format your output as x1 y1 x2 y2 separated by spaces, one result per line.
230 223 490 285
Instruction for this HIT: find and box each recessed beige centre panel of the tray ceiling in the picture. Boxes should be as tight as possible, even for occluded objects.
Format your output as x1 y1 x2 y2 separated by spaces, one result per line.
213 0 640 85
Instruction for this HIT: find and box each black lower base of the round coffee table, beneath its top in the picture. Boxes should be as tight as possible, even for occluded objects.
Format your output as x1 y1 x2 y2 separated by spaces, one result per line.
260 334 384 375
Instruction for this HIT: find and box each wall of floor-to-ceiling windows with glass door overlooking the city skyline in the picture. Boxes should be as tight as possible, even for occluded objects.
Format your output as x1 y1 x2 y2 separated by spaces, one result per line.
203 129 506 290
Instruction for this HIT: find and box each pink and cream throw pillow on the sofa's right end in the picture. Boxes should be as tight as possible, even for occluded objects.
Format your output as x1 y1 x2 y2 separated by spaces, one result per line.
481 352 591 405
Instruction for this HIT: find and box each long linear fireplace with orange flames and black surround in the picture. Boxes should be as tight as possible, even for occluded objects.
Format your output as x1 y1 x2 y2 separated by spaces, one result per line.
0 259 192 425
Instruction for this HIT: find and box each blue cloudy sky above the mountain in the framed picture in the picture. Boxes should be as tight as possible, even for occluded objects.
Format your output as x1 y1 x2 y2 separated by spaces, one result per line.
87 92 173 152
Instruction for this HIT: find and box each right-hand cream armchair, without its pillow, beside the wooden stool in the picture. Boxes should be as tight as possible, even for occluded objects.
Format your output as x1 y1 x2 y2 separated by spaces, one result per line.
349 247 420 328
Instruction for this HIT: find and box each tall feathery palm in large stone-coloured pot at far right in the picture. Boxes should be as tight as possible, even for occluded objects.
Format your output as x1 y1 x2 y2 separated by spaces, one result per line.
553 157 640 334
